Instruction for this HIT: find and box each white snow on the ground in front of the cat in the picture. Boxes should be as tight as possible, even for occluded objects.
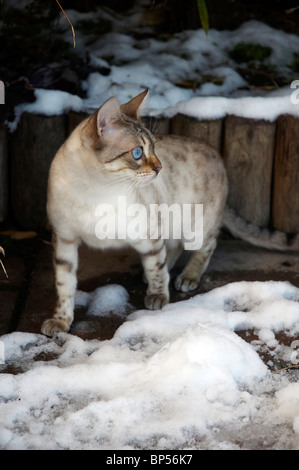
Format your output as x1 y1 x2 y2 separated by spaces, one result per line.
0 281 299 450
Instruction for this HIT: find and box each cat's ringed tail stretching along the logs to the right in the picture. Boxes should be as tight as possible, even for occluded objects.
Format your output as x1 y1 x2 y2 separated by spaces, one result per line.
223 206 299 251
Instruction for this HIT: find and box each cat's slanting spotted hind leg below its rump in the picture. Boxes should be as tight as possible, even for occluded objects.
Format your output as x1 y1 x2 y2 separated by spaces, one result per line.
174 239 216 292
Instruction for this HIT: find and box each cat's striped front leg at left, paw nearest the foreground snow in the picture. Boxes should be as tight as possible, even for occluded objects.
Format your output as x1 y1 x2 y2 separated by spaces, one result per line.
41 234 78 336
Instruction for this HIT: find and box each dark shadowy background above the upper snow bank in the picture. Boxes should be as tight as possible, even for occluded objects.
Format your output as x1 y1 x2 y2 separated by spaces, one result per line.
0 0 299 126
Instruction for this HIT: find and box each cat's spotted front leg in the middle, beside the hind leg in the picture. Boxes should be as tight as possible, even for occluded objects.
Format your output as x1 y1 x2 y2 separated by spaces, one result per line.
141 239 169 310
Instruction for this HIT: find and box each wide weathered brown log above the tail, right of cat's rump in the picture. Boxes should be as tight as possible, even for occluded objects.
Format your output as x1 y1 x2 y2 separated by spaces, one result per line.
223 116 276 226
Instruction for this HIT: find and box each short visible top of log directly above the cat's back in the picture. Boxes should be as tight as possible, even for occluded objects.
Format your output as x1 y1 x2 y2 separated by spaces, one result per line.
171 114 223 152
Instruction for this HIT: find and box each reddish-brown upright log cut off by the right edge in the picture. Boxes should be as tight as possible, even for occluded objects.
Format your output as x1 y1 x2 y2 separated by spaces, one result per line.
272 115 299 233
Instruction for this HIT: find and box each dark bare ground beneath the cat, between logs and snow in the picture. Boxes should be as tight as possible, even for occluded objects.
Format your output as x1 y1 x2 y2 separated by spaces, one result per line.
0 229 299 372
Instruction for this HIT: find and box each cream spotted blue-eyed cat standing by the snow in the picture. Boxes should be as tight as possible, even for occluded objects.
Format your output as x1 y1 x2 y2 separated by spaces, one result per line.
42 90 299 336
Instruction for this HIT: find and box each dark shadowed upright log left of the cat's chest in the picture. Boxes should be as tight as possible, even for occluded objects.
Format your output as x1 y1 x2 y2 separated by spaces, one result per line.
10 113 66 230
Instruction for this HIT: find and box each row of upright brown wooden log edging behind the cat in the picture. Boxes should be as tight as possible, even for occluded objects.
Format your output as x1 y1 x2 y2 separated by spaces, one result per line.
5 112 299 233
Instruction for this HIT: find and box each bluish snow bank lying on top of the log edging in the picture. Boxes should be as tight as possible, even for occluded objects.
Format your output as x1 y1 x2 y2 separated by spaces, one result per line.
9 6 299 131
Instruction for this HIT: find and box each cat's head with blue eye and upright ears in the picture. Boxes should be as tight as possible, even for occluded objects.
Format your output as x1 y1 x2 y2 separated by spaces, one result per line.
84 90 162 184
